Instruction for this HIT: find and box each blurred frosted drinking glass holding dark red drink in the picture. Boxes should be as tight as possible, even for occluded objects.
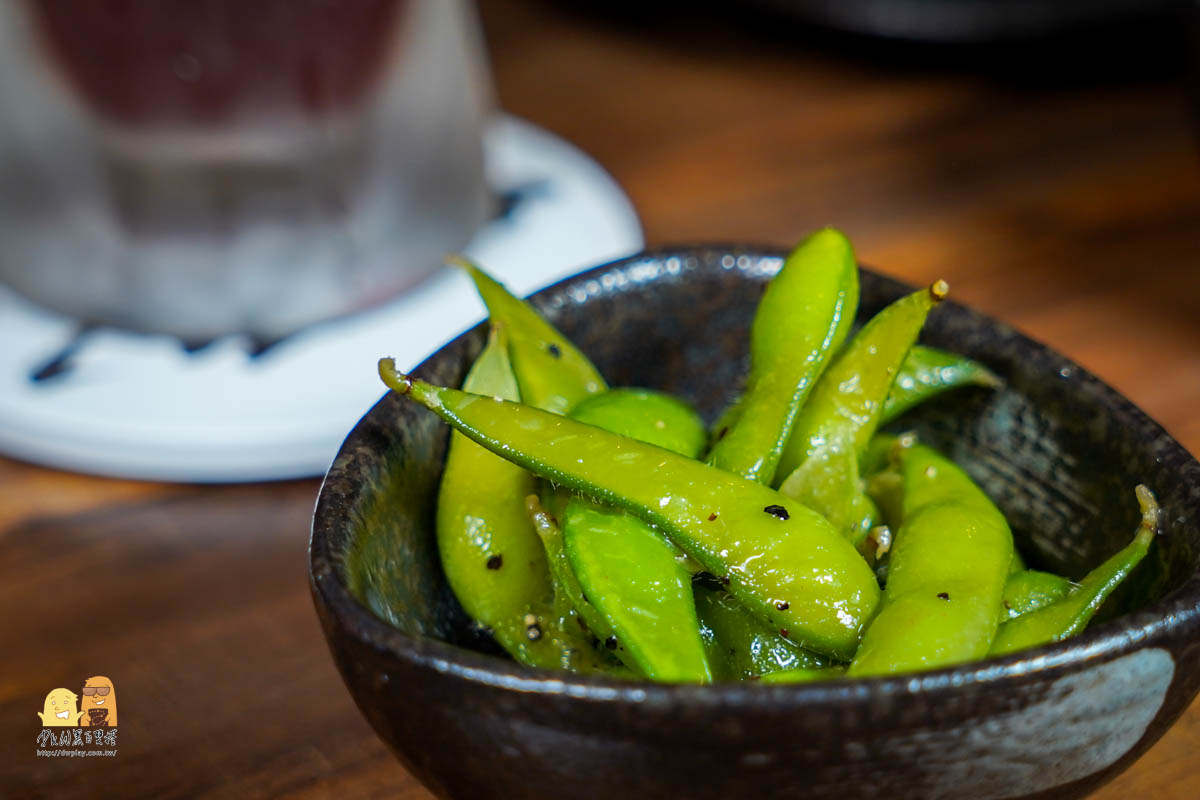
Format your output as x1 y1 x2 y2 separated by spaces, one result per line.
0 0 490 343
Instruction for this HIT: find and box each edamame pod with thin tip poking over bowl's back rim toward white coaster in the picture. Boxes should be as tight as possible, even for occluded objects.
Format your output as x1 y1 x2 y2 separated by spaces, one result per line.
450 257 607 414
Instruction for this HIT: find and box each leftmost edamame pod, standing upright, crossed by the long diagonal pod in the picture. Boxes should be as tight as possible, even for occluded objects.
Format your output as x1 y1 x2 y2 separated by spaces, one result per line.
437 327 588 669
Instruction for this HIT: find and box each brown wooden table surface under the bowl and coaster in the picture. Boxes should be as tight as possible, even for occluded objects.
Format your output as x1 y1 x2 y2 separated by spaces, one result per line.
0 0 1200 800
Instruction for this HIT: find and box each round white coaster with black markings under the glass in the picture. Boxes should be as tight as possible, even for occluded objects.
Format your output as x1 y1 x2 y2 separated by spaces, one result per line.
0 116 642 482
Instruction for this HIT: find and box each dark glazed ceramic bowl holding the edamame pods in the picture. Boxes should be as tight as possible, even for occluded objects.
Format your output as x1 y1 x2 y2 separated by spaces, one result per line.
310 248 1200 800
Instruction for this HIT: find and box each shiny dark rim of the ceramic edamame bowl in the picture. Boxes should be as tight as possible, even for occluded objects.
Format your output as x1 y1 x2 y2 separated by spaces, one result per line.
308 243 1200 709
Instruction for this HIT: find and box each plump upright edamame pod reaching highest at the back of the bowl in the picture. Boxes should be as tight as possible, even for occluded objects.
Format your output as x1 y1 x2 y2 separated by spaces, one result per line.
708 228 858 483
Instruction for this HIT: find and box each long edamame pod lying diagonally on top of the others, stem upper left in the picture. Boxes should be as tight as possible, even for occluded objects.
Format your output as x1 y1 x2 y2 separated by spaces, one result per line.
379 359 883 660
